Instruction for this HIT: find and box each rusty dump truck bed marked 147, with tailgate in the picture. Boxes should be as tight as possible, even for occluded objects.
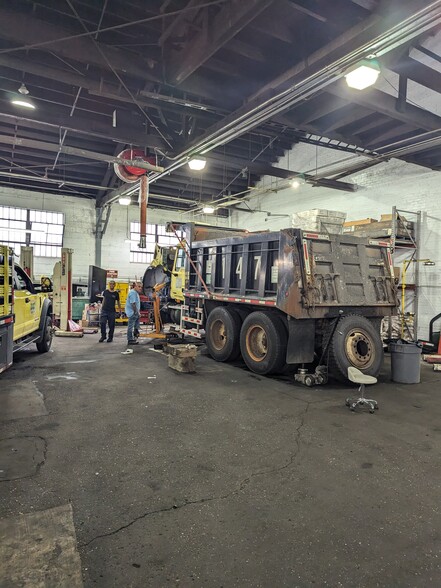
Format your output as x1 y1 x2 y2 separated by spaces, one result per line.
186 229 396 319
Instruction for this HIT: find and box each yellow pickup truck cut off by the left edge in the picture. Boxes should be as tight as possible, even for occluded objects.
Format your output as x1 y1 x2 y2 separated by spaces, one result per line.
0 245 53 372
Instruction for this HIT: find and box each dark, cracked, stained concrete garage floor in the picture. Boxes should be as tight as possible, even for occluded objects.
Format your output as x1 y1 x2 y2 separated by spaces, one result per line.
0 331 441 588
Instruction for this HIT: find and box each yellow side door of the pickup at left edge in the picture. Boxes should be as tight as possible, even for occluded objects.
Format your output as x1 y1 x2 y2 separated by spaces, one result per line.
14 266 41 341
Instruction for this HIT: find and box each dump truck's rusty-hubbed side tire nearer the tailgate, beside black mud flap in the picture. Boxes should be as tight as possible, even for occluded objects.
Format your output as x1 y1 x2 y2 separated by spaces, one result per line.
240 311 288 375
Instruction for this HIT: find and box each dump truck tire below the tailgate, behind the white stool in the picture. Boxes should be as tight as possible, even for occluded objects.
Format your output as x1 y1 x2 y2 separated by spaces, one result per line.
325 314 384 380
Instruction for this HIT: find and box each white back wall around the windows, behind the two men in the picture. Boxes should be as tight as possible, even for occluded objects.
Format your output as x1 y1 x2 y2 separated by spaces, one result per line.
0 186 228 282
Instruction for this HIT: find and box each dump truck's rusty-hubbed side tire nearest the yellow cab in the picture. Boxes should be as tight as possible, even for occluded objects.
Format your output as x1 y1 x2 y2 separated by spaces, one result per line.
205 306 242 361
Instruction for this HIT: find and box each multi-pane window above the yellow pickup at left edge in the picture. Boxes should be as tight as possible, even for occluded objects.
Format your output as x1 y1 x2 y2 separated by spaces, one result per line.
0 206 64 257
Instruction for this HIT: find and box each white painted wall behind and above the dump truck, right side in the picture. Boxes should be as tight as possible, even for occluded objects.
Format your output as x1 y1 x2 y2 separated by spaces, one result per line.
230 145 441 337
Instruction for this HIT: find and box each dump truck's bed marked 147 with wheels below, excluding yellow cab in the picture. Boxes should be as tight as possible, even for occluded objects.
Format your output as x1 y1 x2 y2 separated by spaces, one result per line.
180 228 397 379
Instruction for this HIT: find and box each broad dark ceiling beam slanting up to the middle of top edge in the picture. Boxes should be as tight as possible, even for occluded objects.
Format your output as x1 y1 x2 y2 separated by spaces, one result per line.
166 0 274 85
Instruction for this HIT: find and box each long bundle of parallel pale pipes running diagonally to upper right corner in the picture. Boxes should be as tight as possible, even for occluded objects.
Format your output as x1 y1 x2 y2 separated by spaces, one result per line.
111 0 441 198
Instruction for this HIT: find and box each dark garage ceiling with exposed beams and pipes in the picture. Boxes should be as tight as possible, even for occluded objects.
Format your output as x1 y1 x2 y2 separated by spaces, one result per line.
0 0 441 214
